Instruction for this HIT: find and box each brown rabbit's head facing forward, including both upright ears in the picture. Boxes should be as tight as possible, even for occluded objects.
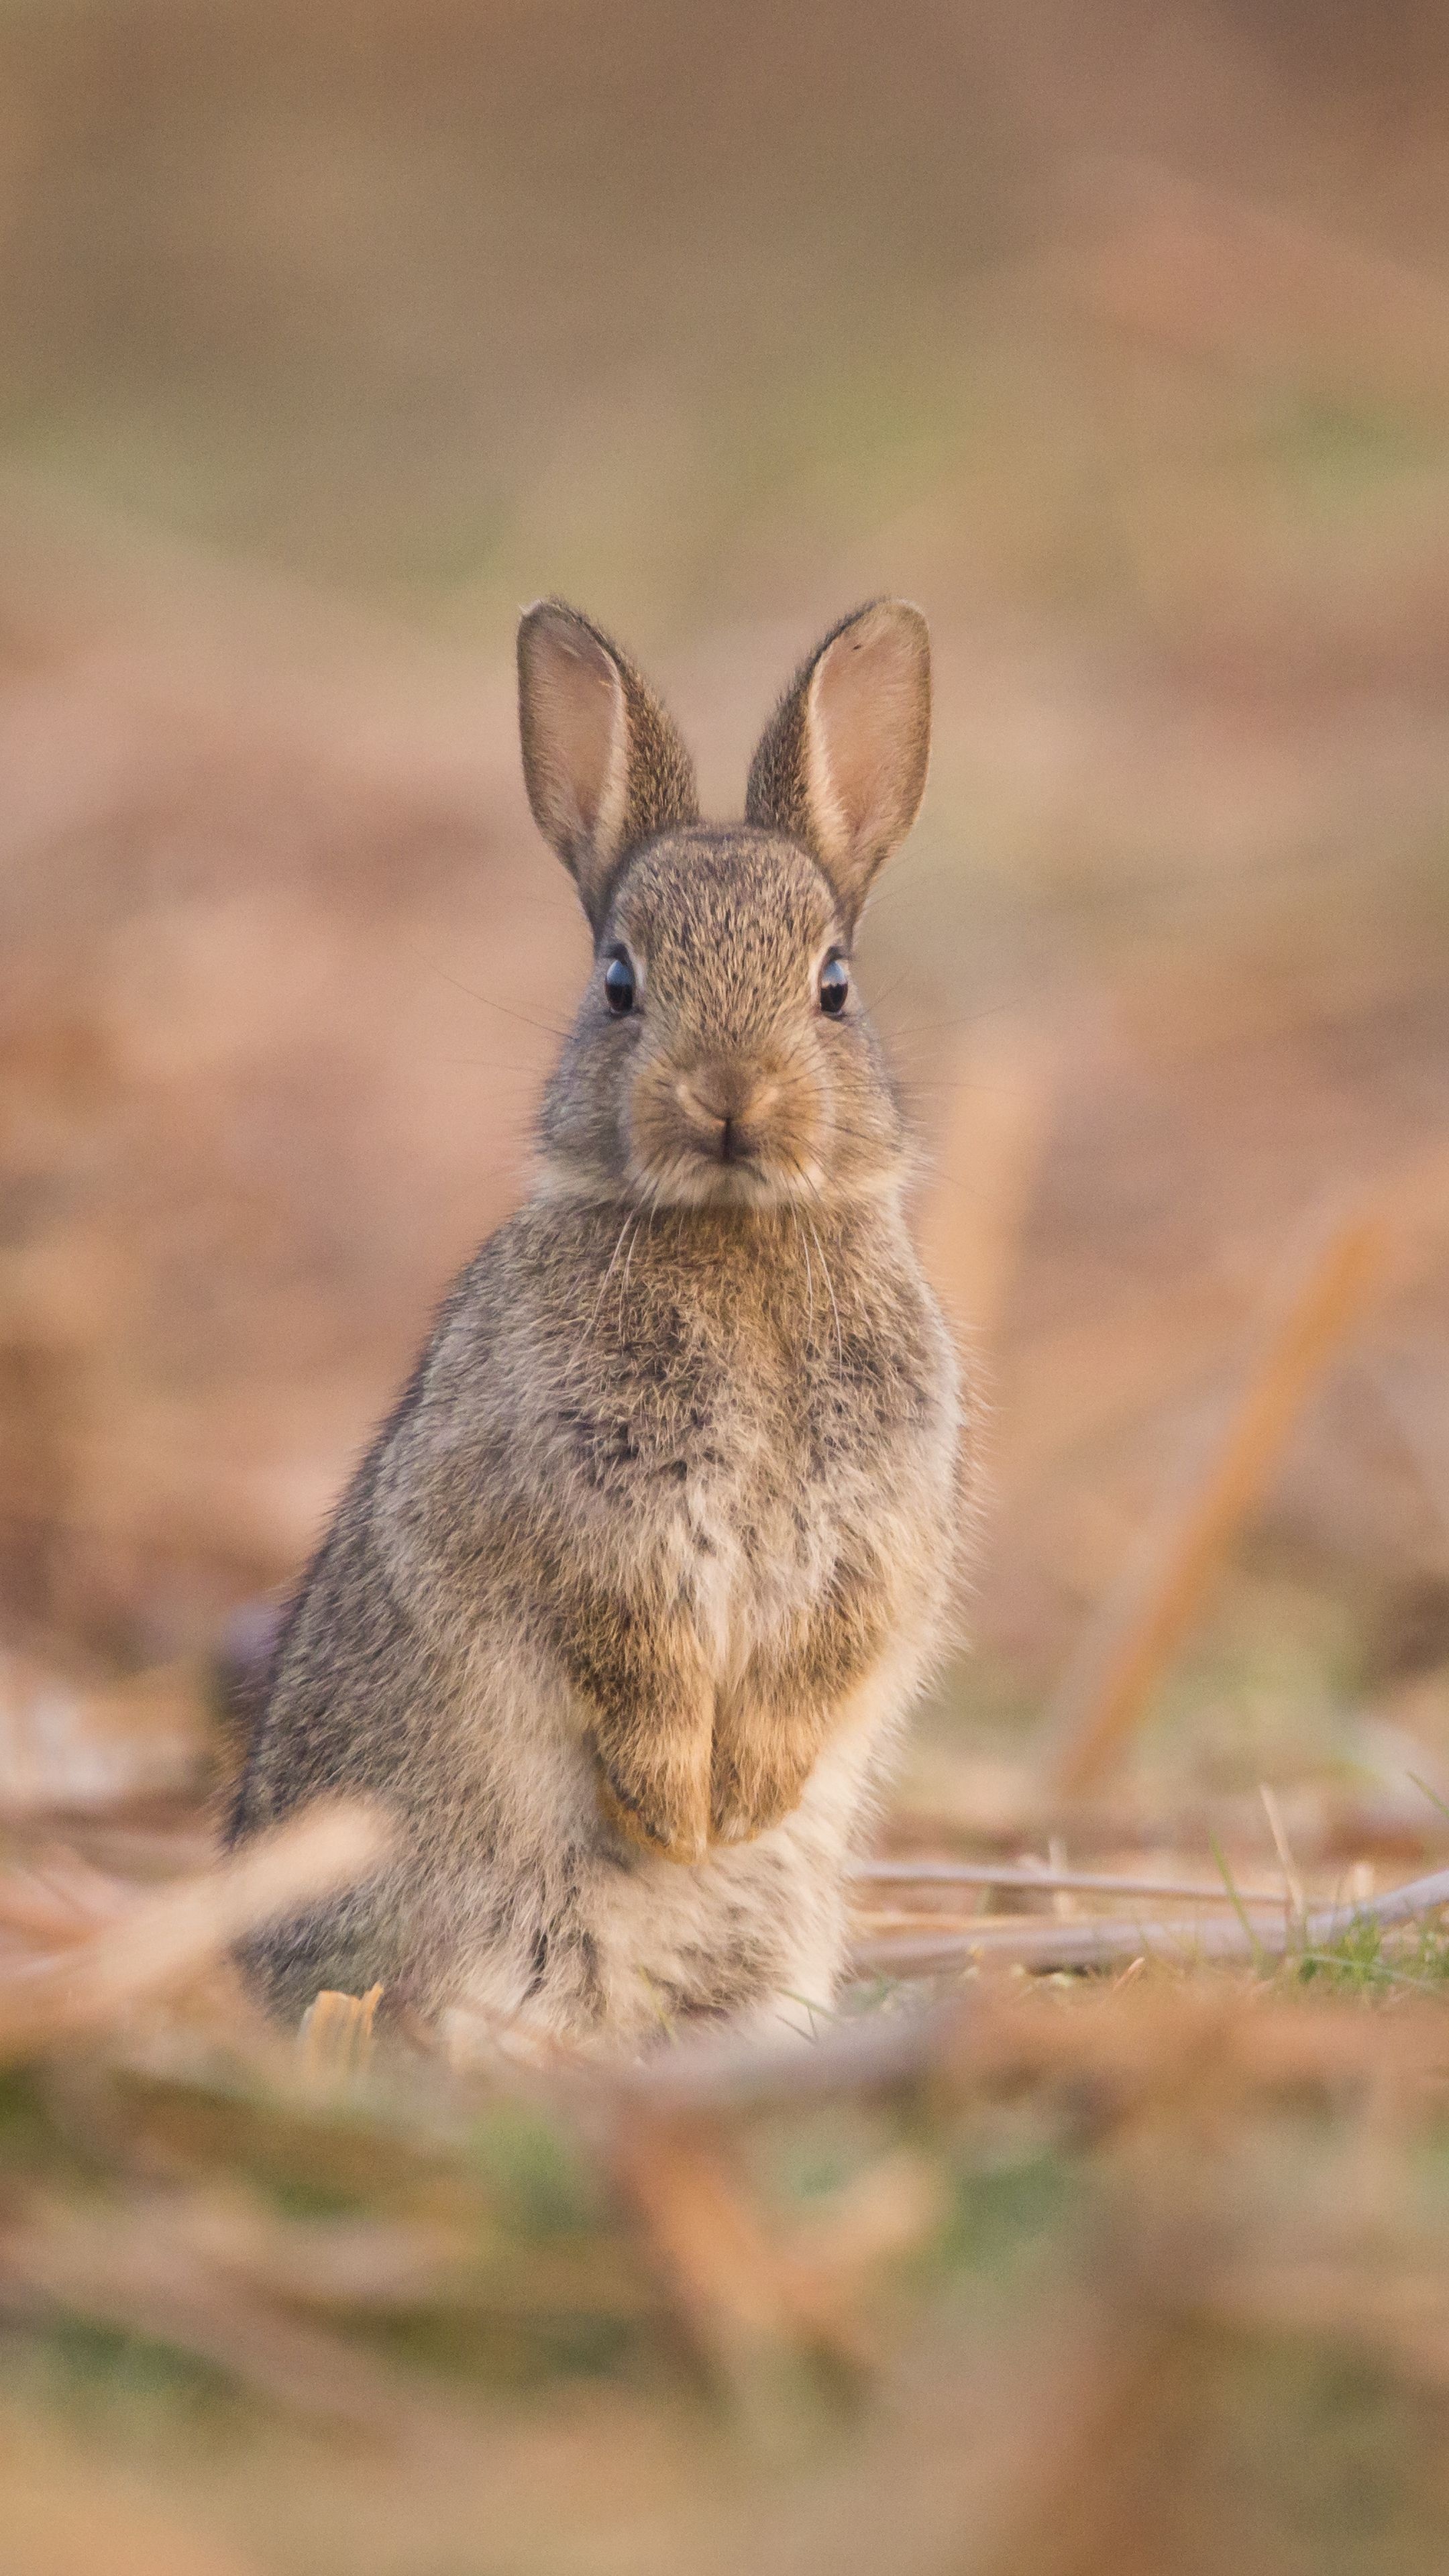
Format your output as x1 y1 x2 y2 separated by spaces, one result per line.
519 600 930 1205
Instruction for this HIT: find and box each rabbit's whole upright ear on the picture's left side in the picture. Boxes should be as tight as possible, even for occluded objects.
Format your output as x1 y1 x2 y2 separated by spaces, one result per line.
519 600 699 930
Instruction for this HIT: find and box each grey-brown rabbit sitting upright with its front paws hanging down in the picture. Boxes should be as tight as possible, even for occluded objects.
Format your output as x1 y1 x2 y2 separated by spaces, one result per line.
229 600 967 2051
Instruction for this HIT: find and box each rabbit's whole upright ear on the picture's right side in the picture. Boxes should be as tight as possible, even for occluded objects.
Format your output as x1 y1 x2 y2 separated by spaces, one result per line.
745 600 930 927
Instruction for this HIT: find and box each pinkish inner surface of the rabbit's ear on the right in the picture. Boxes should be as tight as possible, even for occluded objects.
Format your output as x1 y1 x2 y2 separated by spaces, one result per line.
810 605 930 858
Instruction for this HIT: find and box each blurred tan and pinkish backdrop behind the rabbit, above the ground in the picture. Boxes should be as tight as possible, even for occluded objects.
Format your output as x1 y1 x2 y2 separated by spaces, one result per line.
0 0 1449 1801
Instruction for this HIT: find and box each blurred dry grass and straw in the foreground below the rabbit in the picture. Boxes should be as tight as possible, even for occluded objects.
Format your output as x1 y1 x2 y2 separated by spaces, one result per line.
0 1844 1449 2571
